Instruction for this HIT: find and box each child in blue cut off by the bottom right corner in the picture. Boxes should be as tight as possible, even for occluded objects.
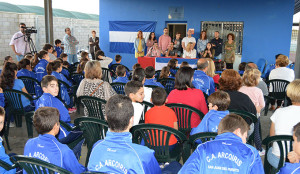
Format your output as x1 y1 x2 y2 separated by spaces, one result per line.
279 123 300 174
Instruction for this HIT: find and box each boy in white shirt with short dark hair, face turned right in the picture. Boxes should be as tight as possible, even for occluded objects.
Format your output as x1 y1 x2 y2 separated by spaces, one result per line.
124 81 145 125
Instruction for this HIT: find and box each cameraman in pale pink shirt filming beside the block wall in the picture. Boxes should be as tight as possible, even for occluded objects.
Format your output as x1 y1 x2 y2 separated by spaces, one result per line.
9 23 30 61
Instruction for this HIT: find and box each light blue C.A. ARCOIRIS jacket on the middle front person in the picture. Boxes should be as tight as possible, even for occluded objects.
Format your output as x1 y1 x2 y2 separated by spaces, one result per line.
88 131 161 174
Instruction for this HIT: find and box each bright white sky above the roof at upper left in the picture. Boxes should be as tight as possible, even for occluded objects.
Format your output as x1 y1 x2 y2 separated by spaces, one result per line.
0 0 100 15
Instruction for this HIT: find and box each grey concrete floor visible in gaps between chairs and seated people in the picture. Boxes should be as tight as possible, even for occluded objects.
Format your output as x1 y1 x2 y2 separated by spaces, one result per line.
3 106 273 165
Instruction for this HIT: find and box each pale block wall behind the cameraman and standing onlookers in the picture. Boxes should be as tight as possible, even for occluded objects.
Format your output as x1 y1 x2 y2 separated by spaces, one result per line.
0 12 99 65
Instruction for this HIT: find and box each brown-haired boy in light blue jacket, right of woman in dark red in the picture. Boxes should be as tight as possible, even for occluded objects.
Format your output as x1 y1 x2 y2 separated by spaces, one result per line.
191 90 230 135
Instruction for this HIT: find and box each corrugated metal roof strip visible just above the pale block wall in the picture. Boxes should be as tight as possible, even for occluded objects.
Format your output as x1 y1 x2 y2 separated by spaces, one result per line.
0 2 99 21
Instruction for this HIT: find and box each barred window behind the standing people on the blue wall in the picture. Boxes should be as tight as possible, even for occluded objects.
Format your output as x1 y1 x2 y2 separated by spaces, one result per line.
201 21 244 54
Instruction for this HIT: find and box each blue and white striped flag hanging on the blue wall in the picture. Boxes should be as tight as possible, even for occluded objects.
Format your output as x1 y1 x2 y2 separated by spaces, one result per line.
109 21 156 54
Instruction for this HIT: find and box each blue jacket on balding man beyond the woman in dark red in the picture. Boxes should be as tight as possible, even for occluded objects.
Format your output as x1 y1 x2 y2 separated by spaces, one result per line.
193 70 215 95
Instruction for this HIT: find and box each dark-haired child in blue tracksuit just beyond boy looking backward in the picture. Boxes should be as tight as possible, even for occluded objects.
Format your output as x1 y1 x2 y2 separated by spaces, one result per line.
47 61 72 107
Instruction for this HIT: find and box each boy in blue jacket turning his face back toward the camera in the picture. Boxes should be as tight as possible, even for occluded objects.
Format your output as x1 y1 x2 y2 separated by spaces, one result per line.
35 75 73 139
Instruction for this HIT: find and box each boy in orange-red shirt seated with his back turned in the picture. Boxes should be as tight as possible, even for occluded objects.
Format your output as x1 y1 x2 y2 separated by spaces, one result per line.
145 87 178 145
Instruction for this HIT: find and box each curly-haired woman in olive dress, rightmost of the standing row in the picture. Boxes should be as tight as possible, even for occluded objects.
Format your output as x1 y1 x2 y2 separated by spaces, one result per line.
224 33 236 69
